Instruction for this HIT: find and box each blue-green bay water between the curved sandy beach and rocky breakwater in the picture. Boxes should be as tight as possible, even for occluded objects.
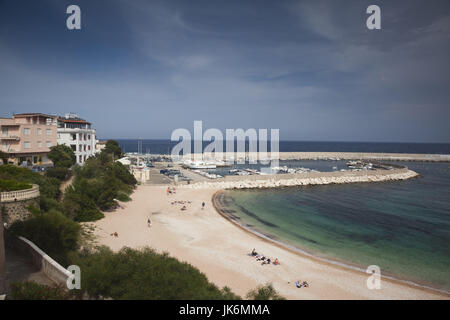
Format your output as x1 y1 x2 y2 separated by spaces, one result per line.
224 163 450 291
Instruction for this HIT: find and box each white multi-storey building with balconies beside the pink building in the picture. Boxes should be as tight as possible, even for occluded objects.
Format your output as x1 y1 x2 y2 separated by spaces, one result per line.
57 113 97 165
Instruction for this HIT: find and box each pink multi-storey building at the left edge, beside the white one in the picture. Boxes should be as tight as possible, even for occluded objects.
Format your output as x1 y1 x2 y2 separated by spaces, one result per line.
0 113 58 165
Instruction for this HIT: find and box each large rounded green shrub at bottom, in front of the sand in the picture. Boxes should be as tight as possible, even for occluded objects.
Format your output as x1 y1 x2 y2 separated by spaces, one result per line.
72 247 240 300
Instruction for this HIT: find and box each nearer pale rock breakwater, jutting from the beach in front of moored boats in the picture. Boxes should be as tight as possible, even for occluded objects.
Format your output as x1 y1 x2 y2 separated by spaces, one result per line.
181 168 419 189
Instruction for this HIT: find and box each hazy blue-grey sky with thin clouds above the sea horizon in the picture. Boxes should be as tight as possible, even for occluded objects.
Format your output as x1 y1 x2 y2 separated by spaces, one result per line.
0 0 450 143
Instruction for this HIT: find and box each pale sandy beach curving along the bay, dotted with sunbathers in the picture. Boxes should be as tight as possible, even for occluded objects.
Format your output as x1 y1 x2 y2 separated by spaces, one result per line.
93 186 449 299
